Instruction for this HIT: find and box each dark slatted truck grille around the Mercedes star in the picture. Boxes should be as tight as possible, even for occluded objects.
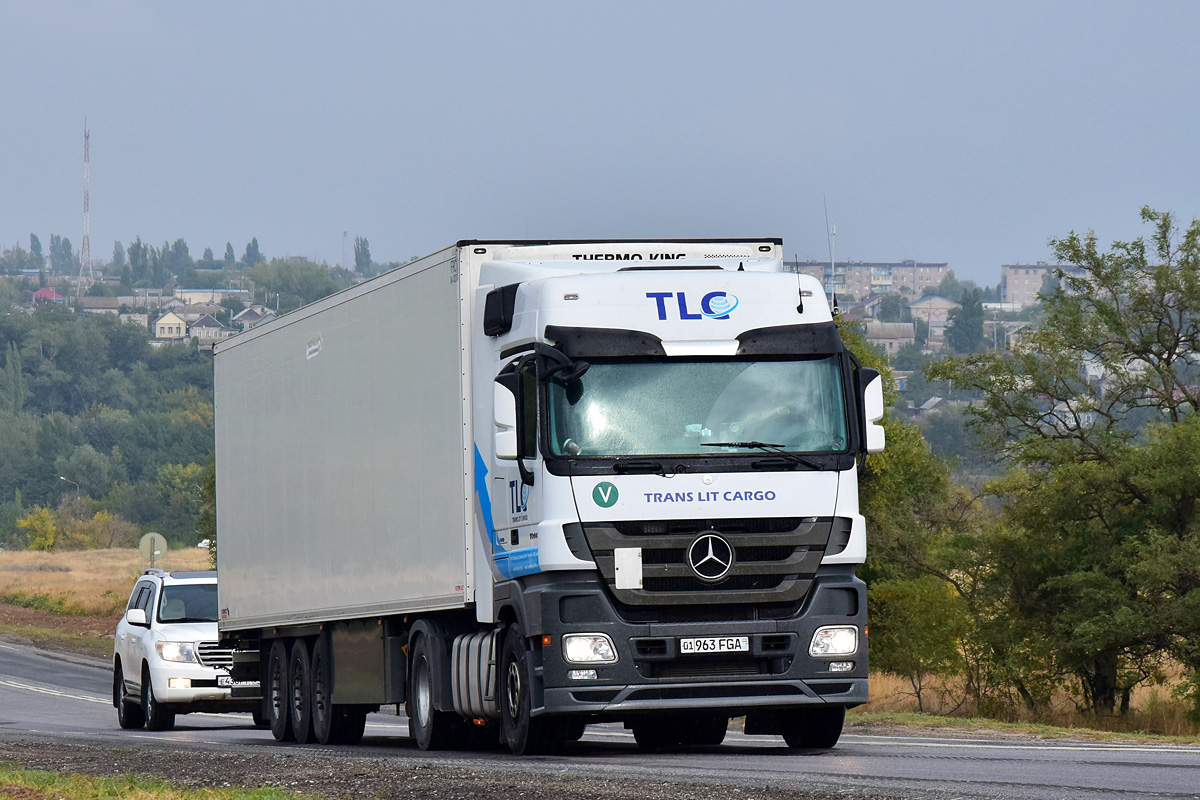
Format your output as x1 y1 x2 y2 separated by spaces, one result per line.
578 517 851 607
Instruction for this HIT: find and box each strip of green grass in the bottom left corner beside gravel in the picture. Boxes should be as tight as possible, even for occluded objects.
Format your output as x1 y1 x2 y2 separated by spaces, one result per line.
0 764 311 800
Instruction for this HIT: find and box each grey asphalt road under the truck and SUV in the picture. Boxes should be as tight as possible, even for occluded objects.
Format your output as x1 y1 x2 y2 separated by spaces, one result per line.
0 642 1200 800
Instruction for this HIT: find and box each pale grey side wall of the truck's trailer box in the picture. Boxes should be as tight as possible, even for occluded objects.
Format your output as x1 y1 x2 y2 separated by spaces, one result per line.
215 247 475 630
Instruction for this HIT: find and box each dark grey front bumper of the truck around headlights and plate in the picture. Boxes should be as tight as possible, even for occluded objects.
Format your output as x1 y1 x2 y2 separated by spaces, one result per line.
501 566 869 718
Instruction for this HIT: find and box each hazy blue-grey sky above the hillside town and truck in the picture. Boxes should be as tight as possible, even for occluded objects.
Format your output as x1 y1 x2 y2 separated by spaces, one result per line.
0 0 1200 285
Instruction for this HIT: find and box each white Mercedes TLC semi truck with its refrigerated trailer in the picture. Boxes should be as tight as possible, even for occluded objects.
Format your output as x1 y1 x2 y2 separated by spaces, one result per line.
215 239 883 753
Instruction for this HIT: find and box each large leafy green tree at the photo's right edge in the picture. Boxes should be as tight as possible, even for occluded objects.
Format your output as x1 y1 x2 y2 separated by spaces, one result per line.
930 209 1200 714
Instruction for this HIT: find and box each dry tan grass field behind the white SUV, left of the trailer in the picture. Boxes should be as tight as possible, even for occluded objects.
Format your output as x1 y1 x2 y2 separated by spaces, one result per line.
0 547 209 616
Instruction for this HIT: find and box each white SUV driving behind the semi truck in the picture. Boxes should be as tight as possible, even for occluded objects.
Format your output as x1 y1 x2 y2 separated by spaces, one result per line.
113 570 262 730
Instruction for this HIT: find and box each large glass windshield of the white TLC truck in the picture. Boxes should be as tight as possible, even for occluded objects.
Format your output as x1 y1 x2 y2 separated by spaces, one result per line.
547 356 847 458
